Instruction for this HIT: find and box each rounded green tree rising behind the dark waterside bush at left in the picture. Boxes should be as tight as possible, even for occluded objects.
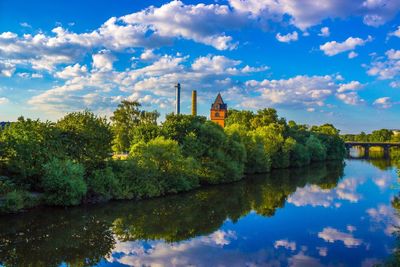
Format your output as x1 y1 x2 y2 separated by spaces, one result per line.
57 110 112 171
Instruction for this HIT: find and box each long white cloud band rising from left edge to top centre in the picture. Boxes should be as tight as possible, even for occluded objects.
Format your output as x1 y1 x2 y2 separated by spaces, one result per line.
0 1 249 75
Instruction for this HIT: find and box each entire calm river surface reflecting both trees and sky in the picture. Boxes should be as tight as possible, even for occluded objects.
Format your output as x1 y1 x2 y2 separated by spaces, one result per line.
0 160 400 266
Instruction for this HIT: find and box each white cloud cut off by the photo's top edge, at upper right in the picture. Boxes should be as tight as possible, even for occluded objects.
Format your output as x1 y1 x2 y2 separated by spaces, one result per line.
229 0 400 30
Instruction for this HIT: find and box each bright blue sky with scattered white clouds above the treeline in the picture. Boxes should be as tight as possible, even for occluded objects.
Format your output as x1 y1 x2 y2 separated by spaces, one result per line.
0 0 400 133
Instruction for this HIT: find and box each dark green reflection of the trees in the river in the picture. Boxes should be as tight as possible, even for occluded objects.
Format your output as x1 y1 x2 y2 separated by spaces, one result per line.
0 162 344 266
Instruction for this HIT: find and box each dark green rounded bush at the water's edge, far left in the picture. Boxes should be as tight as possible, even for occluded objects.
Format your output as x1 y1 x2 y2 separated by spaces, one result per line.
41 159 87 206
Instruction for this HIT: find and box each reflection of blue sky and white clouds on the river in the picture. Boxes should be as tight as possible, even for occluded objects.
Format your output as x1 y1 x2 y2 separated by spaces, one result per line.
100 161 400 266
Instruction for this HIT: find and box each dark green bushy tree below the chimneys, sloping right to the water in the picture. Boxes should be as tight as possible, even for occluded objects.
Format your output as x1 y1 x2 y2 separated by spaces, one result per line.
162 115 246 184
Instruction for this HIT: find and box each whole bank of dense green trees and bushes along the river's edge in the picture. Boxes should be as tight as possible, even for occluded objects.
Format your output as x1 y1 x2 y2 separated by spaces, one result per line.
0 101 346 214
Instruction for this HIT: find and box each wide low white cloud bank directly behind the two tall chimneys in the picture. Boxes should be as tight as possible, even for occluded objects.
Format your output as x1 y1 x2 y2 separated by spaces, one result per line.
28 52 265 115
